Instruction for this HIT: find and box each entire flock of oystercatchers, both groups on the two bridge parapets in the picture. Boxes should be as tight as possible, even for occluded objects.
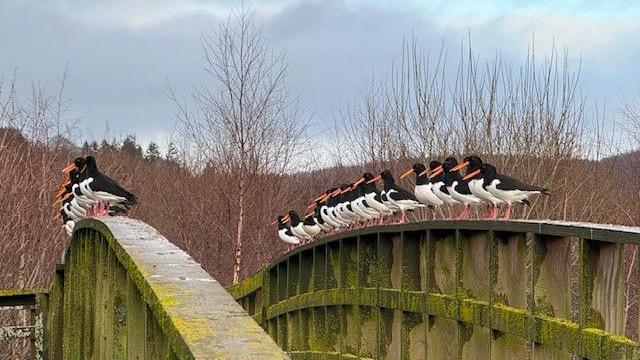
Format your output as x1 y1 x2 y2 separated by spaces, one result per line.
54 155 550 245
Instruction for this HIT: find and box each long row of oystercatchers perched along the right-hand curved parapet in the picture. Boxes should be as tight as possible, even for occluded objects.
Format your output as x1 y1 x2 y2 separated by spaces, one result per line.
272 155 550 245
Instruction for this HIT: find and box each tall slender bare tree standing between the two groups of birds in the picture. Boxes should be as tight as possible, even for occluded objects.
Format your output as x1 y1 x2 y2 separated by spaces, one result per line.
174 9 308 283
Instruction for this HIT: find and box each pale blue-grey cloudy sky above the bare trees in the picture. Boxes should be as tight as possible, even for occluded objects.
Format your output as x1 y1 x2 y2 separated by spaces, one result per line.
0 0 640 148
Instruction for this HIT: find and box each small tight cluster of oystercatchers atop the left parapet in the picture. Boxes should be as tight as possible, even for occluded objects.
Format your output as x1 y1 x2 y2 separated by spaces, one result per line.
53 156 138 236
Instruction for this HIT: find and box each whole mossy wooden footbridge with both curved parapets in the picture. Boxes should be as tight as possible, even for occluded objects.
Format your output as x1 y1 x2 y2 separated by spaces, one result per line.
0 218 640 359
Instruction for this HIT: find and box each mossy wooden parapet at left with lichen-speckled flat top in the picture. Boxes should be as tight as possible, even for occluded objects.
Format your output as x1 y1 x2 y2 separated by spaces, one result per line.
7 217 288 359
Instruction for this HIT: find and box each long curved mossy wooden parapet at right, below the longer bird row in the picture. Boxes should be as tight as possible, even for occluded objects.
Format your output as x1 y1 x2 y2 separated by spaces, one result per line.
228 221 640 359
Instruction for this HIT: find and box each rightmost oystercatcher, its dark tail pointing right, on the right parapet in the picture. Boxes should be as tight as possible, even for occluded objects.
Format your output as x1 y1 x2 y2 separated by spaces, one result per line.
476 163 551 219
